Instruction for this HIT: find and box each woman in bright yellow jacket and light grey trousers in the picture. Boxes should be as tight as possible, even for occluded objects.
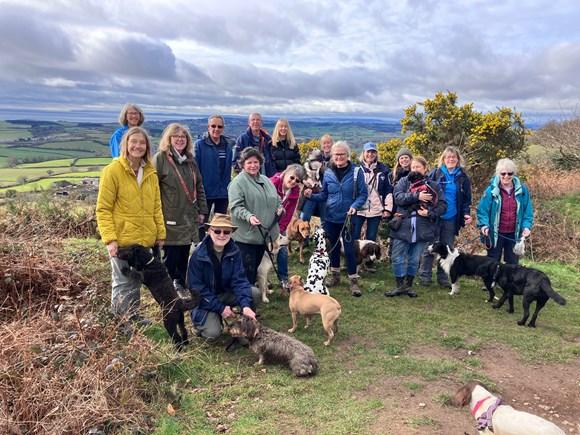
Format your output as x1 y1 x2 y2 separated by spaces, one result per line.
96 127 165 325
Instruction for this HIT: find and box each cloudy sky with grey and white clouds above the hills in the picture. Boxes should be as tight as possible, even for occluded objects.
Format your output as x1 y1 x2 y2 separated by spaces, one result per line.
0 0 580 116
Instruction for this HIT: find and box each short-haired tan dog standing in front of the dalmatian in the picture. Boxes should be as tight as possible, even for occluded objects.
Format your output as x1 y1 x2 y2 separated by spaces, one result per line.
288 275 341 346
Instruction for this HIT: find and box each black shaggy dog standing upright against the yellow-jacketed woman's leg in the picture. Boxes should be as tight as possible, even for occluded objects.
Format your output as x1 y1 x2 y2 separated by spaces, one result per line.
117 245 199 350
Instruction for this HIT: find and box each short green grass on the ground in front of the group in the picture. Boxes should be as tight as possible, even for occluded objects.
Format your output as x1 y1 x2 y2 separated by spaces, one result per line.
138 252 580 434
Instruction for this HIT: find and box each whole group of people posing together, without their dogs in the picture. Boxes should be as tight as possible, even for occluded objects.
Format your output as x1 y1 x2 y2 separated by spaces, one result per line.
96 104 533 339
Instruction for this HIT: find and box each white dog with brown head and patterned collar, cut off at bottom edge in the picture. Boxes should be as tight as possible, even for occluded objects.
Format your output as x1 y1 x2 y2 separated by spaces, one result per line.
453 382 565 435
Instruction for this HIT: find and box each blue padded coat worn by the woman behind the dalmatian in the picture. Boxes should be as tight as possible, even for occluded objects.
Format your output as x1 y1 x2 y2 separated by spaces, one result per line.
310 162 368 224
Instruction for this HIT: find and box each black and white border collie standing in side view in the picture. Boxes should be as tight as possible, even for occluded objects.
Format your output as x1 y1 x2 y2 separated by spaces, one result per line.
427 242 499 302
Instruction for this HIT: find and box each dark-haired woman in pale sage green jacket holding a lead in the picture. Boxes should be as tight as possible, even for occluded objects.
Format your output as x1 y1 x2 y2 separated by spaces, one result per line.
228 147 284 285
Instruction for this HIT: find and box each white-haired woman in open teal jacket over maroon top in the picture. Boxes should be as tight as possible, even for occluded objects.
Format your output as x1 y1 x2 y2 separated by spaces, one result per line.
477 159 534 264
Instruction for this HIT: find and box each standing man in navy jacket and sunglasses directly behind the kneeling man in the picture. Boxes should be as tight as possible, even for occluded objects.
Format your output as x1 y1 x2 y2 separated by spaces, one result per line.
195 115 234 240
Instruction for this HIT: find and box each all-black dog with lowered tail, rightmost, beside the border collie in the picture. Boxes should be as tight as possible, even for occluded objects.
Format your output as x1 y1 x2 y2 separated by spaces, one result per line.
493 264 566 328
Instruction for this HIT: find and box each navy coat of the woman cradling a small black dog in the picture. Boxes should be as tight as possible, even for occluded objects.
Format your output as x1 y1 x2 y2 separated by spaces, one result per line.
389 177 447 243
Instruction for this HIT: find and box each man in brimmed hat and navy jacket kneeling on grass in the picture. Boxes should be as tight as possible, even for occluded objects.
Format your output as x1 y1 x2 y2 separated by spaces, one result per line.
187 213 261 340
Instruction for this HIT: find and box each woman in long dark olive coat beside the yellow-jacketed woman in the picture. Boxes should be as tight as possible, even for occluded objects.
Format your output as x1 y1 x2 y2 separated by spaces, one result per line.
153 123 208 291
